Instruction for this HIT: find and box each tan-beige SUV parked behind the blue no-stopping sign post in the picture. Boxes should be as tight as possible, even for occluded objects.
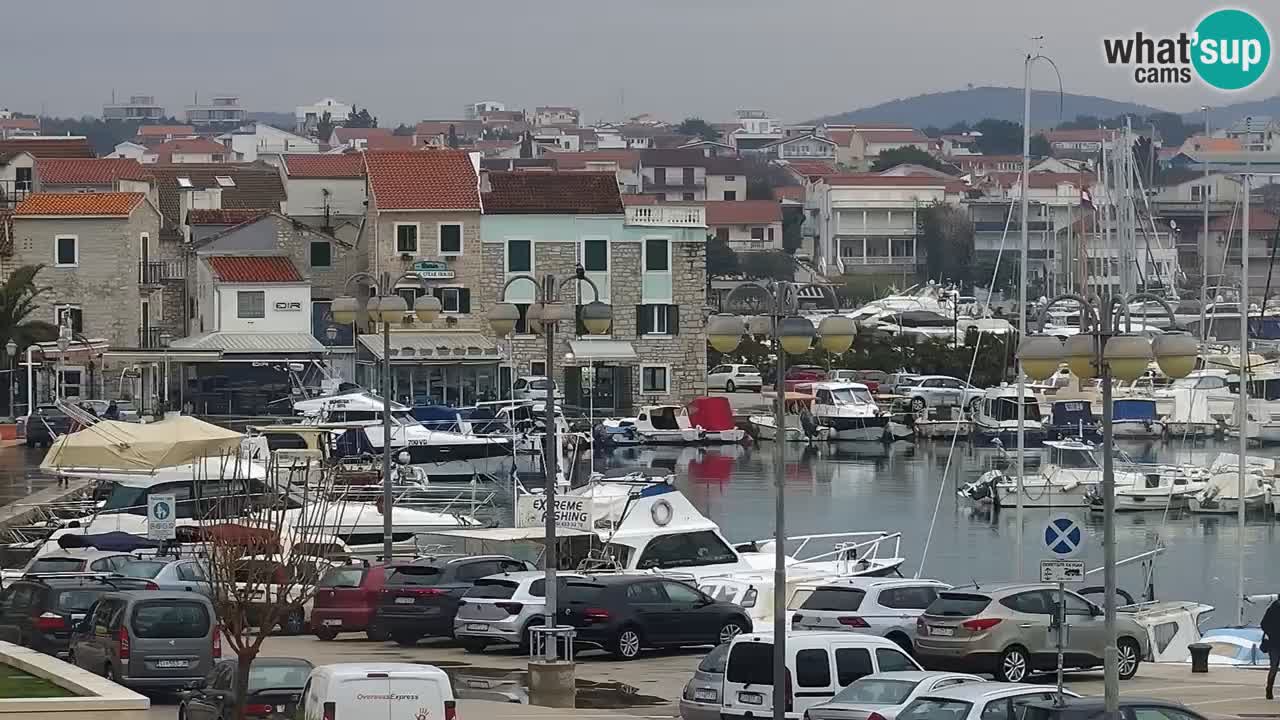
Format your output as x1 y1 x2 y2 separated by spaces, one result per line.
914 584 1148 683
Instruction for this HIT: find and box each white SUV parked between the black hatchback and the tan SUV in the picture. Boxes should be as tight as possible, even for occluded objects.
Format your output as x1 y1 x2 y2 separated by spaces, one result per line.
787 578 951 652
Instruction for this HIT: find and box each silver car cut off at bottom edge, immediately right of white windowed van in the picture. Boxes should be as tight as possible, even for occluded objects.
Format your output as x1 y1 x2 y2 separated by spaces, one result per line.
804 670 986 720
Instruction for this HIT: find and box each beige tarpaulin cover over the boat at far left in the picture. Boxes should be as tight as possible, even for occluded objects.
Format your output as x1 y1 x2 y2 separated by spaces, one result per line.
40 415 243 471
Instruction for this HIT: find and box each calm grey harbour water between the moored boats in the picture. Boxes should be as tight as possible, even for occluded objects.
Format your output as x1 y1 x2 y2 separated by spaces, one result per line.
596 442 1280 624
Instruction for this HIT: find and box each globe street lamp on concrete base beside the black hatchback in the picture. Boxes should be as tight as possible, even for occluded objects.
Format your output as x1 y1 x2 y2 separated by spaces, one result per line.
489 265 613 662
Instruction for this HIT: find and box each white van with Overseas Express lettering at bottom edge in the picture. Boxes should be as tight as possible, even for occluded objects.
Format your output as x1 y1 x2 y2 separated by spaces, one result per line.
296 662 457 720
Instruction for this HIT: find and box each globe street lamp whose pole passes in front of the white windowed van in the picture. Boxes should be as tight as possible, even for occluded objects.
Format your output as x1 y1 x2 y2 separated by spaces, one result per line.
707 282 858 720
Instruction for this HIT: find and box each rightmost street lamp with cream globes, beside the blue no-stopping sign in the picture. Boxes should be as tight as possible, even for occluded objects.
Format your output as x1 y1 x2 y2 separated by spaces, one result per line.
1018 292 1192 717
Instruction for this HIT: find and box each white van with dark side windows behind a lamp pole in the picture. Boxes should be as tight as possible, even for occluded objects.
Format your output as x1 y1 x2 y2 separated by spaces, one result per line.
721 632 923 720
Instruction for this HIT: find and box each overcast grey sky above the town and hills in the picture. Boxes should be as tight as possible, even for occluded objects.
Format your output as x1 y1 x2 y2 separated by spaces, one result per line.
0 0 1280 126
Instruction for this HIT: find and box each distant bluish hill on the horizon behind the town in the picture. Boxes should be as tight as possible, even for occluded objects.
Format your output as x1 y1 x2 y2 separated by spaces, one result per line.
818 87 1165 128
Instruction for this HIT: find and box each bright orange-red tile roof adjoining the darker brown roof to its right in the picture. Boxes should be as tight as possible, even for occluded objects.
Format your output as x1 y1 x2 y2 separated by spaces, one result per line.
365 150 480 210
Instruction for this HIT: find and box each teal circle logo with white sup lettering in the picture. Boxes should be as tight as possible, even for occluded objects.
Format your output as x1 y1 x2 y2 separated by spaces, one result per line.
1192 9 1271 90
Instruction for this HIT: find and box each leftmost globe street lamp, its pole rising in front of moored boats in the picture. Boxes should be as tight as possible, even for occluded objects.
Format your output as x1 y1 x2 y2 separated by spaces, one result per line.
325 272 440 562
